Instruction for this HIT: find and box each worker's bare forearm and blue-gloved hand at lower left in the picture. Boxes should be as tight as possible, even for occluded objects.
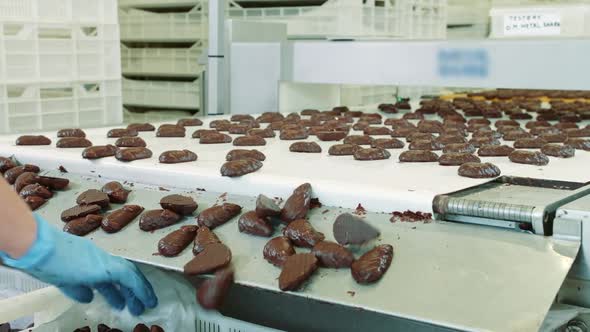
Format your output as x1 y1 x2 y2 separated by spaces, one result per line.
0 179 157 315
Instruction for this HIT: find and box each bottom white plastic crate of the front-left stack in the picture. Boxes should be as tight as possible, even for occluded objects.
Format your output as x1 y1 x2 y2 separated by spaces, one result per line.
0 80 123 134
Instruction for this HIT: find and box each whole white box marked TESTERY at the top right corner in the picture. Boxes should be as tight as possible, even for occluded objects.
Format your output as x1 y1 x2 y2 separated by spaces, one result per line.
490 2 590 38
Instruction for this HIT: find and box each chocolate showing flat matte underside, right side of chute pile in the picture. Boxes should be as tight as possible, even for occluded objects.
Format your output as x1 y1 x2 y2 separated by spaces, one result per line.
332 213 381 245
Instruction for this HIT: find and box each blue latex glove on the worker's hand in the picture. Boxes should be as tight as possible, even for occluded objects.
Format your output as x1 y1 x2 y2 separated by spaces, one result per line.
0 215 158 316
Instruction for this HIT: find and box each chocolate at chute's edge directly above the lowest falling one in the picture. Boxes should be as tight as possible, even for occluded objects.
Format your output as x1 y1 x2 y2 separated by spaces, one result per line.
184 243 232 275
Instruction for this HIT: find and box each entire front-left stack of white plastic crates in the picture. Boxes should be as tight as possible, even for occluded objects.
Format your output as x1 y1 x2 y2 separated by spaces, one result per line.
0 0 122 134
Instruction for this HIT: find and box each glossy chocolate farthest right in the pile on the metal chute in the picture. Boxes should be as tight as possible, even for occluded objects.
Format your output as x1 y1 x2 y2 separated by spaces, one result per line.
350 244 393 284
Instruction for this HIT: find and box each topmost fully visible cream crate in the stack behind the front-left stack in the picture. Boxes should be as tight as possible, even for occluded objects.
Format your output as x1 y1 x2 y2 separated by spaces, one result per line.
119 5 207 42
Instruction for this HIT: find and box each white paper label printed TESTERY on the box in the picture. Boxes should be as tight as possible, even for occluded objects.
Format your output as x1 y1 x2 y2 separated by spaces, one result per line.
504 13 561 36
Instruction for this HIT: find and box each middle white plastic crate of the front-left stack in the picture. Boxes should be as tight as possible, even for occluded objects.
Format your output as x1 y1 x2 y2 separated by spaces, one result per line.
0 22 121 84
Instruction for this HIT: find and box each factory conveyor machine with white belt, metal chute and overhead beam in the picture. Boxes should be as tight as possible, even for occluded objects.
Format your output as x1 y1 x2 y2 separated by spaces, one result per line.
0 5 590 331
